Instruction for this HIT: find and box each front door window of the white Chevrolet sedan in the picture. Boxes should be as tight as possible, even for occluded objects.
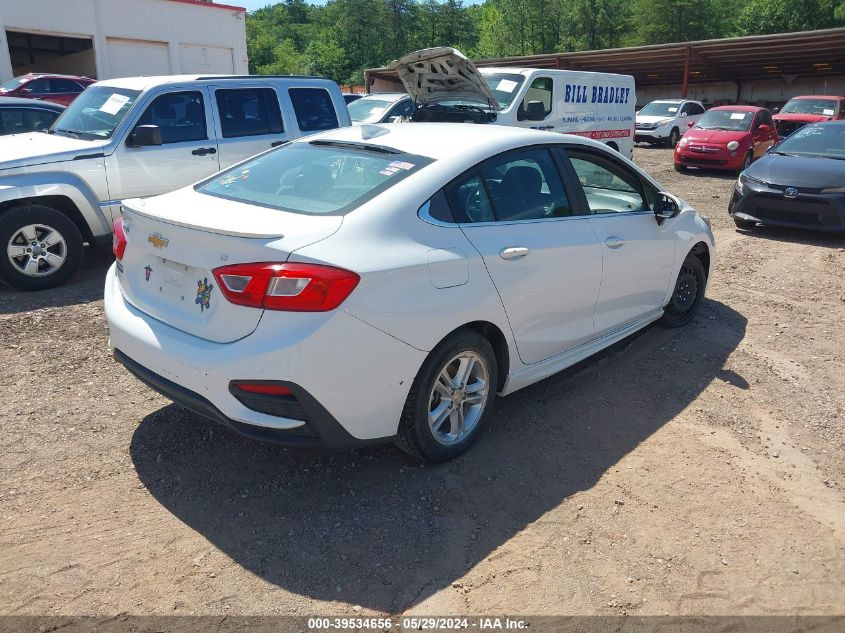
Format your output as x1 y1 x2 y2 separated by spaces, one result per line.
569 149 649 214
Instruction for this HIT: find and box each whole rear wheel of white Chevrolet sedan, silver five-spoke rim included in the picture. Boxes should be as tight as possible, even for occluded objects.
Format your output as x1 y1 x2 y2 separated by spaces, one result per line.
396 330 498 462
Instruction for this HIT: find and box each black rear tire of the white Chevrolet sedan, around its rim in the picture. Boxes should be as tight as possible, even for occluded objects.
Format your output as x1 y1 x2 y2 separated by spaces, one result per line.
395 329 498 462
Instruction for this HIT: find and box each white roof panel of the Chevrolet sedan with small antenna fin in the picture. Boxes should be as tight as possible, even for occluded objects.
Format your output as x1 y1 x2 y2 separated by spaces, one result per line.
296 123 607 159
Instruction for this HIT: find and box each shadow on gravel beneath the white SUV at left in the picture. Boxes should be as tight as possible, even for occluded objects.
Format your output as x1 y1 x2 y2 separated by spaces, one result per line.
0 247 114 314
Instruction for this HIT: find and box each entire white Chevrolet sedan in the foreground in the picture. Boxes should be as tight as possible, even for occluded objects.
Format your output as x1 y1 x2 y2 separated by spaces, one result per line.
105 123 713 461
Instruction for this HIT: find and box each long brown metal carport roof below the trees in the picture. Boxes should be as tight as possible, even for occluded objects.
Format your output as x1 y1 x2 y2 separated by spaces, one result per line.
367 28 845 86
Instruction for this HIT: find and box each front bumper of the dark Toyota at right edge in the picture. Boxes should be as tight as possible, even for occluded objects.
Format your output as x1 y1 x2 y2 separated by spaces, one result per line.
728 190 845 232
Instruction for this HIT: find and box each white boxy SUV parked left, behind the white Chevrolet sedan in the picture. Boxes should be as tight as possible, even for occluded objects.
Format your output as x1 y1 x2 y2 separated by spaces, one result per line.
0 75 350 290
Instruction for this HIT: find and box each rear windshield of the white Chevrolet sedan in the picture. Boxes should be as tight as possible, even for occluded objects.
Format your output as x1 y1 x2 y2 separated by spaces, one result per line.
195 140 433 215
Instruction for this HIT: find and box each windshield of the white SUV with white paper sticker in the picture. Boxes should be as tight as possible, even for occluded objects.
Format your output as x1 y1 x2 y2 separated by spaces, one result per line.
52 85 141 140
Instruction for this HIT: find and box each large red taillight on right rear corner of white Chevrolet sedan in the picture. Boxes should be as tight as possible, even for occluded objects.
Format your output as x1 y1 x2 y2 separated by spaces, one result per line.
212 262 361 312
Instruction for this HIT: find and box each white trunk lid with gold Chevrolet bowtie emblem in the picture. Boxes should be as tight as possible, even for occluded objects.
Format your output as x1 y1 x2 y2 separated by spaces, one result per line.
118 190 342 343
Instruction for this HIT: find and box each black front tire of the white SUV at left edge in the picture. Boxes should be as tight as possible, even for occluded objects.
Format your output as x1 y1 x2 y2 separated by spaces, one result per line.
0 203 84 290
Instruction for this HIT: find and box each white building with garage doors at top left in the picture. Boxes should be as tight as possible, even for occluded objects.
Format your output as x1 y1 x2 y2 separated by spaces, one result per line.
0 0 248 82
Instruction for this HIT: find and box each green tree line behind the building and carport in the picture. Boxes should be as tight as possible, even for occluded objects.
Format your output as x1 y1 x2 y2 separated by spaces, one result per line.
246 0 845 85
